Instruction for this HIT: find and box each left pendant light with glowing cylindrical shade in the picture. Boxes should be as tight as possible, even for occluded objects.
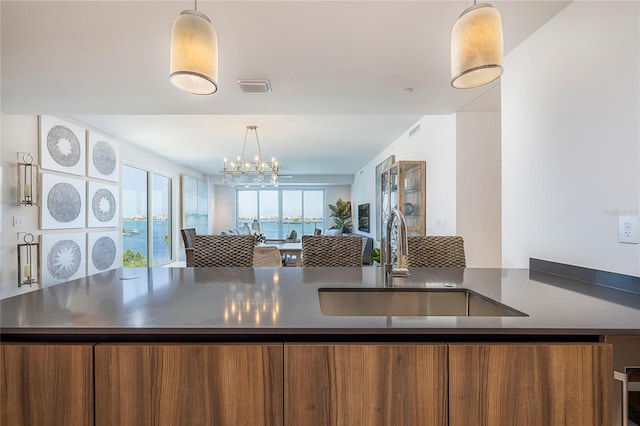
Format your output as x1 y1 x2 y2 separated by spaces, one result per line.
169 0 218 95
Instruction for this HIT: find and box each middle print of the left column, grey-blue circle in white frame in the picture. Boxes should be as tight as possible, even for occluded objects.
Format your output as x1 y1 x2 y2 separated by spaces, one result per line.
40 173 87 229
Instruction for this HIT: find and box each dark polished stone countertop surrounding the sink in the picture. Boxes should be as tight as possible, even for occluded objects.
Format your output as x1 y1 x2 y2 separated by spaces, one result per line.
0 267 640 341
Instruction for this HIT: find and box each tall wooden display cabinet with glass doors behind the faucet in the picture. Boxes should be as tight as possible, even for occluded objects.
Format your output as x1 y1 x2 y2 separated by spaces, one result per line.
379 161 426 238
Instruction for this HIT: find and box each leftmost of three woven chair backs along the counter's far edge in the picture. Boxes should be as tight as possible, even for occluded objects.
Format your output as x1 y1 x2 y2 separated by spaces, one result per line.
187 235 255 267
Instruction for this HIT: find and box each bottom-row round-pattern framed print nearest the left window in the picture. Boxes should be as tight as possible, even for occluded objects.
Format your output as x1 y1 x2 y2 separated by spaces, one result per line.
87 231 122 275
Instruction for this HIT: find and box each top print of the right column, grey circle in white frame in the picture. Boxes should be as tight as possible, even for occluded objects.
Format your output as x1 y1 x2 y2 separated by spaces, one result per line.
87 130 120 182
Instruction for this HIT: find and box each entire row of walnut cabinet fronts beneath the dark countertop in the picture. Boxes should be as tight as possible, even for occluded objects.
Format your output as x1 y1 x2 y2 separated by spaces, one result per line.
0 343 613 426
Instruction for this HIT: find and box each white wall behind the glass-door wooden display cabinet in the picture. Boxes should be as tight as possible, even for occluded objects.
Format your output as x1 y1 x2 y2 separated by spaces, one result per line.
351 115 456 246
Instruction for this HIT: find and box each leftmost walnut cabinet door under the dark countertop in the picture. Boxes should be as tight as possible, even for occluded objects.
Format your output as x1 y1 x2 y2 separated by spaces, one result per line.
0 343 93 426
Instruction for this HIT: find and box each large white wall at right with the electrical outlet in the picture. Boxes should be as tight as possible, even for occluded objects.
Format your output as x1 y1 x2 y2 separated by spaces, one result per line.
502 1 640 276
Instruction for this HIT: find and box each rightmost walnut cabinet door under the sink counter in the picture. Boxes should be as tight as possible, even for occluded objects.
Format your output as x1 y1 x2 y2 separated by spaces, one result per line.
449 344 613 426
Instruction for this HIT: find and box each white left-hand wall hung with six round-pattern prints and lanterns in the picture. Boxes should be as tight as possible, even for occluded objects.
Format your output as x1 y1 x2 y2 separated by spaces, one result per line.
0 113 203 298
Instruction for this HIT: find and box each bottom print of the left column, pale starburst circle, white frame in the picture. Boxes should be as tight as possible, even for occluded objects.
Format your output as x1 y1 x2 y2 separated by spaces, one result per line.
41 232 87 287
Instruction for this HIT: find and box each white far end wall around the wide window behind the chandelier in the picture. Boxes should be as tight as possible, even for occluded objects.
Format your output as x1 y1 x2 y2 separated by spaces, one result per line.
213 185 350 234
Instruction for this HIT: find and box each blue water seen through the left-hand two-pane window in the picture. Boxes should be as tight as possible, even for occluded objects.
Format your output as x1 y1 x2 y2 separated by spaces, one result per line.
122 220 170 263
